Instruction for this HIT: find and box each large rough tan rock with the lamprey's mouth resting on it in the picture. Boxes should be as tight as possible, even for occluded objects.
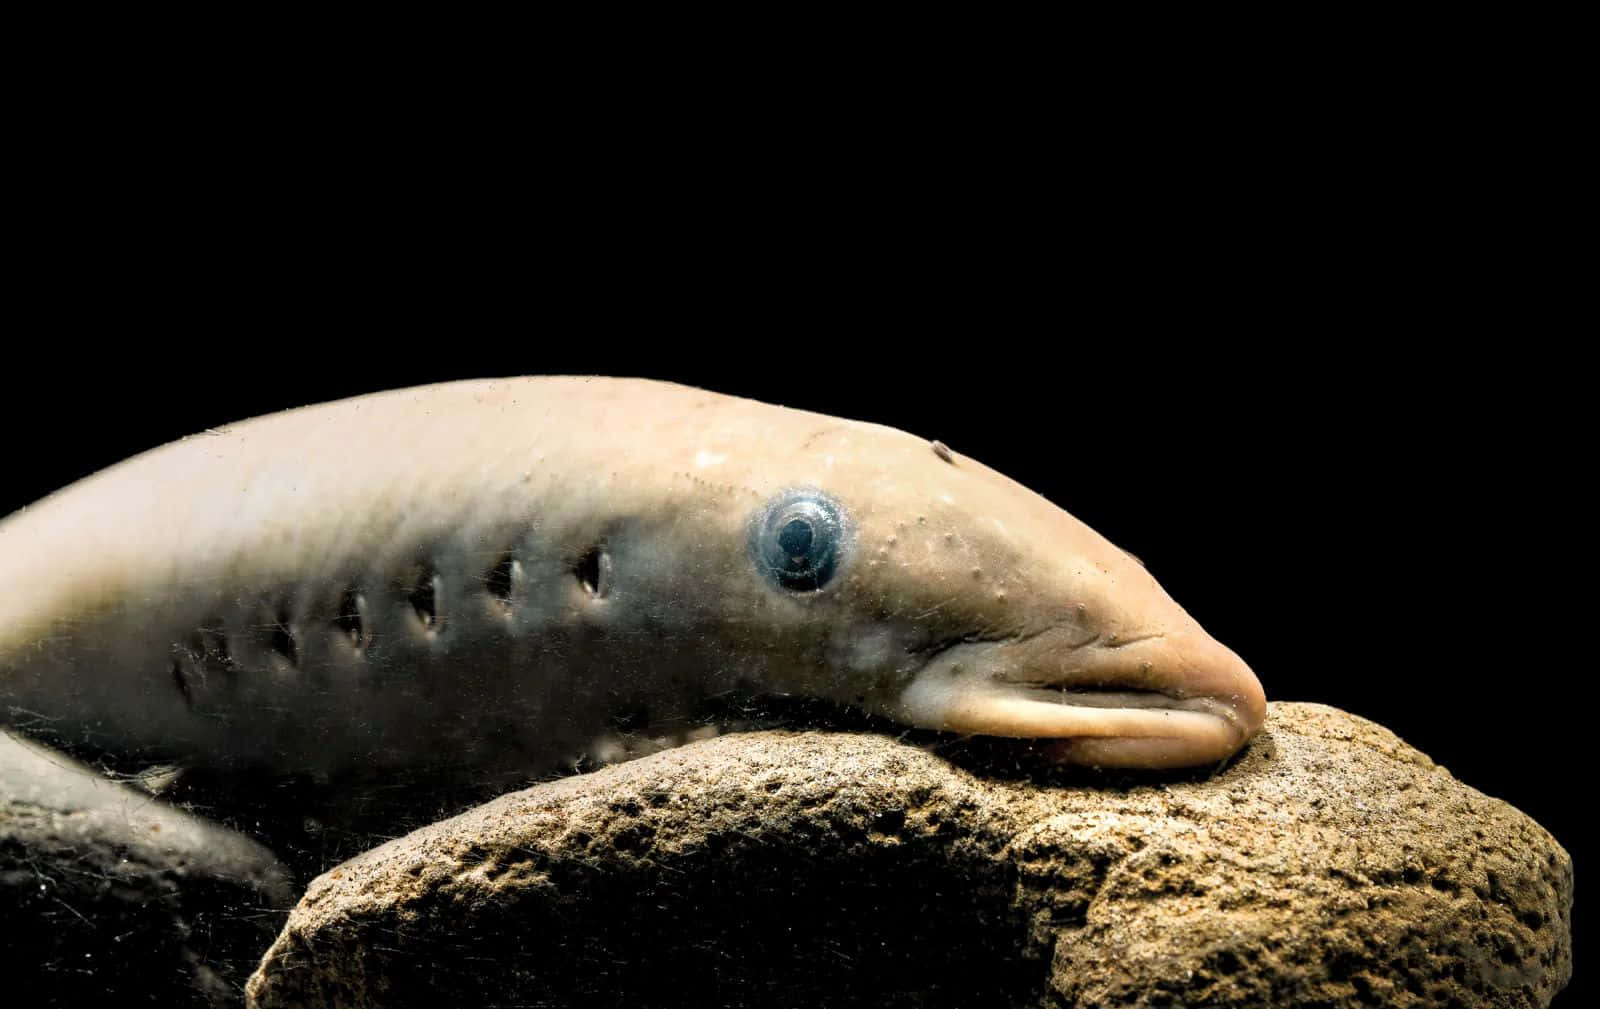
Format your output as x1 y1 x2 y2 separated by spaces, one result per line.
248 704 1573 1009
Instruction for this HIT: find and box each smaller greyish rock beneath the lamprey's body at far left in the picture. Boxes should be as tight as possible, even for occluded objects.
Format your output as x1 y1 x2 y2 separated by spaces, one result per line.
0 732 294 1006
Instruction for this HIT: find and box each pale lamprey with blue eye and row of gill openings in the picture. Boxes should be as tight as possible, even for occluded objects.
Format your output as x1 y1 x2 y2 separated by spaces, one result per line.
0 377 1266 796
